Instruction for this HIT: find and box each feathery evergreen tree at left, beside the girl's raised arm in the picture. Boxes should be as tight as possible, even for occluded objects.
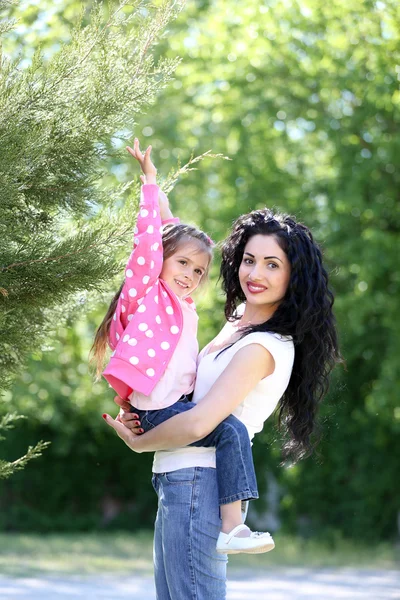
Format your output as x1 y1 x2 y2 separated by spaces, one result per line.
0 0 182 475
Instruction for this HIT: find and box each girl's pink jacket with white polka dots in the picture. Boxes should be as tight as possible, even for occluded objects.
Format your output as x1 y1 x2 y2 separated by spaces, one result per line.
106 186 192 389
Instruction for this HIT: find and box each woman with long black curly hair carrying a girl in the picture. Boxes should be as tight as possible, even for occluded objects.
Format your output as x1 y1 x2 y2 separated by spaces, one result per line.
106 209 339 600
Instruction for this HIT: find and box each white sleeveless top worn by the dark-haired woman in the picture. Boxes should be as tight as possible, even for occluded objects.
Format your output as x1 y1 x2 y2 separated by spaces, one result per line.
153 323 294 473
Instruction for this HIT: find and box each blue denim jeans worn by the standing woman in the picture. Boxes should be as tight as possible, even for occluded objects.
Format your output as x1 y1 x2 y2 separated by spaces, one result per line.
153 467 228 600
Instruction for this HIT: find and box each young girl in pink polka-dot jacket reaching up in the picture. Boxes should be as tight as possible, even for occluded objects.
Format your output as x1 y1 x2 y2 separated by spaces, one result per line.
94 139 274 553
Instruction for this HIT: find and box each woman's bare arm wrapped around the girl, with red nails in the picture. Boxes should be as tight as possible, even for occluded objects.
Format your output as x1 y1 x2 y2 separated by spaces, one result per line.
105 344 275 452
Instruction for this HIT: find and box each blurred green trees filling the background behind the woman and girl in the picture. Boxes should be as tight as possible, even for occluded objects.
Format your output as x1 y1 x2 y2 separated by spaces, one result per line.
0 0 400 542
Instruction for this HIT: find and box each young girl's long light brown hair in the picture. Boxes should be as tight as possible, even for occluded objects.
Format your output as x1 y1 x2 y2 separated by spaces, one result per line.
90 223 214 377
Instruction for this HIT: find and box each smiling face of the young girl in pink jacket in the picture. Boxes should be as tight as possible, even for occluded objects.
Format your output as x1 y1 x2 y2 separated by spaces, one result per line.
160 242 210 298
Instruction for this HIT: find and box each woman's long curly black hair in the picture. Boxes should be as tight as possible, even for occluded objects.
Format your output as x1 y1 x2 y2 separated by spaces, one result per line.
221 209 341 461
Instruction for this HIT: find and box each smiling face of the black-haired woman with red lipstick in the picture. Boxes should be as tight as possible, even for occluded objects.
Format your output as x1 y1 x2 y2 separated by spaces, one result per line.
239 234 291 309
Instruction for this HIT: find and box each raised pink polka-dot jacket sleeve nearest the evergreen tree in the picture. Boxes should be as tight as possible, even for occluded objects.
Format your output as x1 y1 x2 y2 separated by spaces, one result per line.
109 185 163 350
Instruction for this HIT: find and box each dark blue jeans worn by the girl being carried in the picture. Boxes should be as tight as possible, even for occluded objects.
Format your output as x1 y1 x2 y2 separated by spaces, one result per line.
131 396 258 505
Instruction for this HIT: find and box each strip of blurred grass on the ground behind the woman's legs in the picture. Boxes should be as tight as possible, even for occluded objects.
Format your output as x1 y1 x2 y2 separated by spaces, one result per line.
0 532 399 577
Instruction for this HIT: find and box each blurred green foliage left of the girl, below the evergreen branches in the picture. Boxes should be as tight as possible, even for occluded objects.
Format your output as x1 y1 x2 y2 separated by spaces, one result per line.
0 314 156 531
